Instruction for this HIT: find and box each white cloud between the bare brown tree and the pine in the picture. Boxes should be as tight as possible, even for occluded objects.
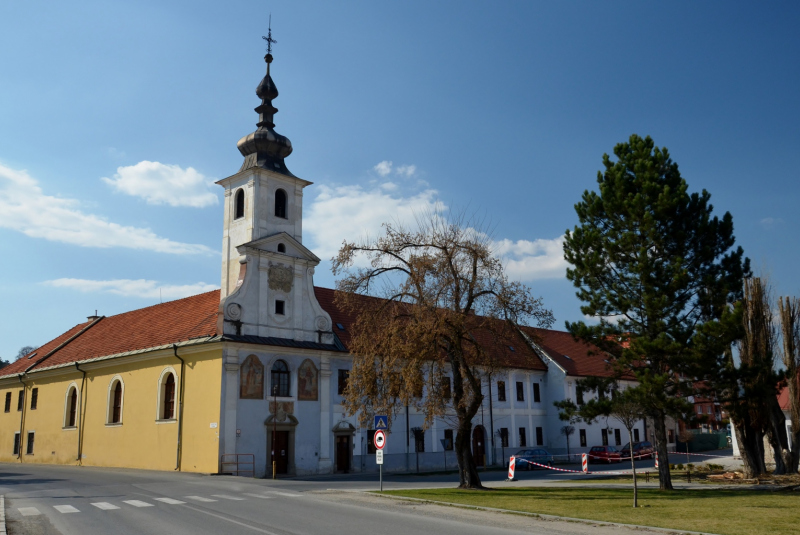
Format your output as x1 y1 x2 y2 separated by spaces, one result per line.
492 236 567 281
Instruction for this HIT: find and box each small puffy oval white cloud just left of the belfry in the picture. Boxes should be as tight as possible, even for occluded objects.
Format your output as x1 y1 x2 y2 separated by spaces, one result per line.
103 160 219 208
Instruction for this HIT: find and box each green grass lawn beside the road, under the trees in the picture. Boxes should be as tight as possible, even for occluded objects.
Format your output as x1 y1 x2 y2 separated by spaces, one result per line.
384 487 800 535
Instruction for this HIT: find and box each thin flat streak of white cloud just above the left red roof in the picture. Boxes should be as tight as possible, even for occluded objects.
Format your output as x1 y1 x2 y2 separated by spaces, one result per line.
43 279 217 299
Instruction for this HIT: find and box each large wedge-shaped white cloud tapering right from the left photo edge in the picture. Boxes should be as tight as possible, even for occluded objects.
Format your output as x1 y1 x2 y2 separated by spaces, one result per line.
0 165 214 254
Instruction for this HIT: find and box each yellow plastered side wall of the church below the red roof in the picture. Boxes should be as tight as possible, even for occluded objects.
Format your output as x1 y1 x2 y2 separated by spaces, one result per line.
0 346 222 473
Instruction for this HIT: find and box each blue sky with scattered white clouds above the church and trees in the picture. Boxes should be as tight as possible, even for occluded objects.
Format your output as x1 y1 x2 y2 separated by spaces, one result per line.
0 0 800 359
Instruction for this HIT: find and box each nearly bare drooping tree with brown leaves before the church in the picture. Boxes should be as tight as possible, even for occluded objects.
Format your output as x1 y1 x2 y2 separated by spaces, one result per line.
333 213 553 488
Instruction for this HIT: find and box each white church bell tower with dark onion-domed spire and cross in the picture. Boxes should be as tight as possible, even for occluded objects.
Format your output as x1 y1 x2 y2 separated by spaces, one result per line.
217 30 333 343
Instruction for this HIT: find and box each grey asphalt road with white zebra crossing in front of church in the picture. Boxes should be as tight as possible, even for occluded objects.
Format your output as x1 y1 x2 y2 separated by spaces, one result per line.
0 448 736 535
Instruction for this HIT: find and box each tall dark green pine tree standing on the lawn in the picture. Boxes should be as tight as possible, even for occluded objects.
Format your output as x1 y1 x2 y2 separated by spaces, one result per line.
564 135 749 489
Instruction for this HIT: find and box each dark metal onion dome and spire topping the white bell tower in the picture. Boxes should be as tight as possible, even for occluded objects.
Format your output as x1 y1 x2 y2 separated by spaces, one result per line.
237 53 294 176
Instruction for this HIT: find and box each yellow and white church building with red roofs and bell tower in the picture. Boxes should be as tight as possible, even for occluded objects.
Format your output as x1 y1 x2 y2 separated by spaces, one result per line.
0 43 672 477
